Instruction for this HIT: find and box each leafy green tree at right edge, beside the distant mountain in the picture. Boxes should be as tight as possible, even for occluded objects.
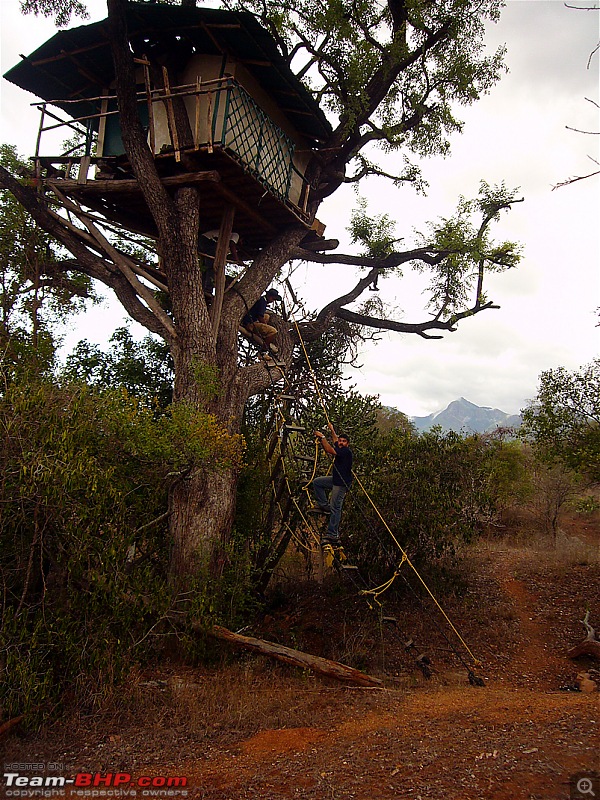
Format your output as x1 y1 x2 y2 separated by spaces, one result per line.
521 359 600 481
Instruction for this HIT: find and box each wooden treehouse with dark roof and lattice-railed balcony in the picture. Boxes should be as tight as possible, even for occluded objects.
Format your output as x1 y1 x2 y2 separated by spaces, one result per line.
5 3 331 256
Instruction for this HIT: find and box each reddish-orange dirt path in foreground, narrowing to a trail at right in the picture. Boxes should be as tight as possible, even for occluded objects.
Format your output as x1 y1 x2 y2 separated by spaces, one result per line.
171 551 600 800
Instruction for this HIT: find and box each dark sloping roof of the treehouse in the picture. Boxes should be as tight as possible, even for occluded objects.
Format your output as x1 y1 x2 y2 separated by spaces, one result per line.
4 3 331 141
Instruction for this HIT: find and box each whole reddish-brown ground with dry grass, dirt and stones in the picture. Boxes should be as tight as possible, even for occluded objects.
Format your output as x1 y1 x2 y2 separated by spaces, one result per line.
2 524 600 800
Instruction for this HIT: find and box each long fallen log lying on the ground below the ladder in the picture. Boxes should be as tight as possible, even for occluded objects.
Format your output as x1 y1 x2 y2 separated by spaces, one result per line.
206 625 382 686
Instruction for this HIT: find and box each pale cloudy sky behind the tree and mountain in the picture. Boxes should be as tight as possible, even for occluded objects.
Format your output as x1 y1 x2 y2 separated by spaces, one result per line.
0 0 600 416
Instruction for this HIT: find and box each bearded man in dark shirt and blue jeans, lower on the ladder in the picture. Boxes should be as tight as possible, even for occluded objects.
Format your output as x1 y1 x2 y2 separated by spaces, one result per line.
313 422 352 545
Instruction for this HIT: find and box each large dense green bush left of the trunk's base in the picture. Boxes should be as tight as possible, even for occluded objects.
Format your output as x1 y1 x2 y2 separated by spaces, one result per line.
0 381 241 716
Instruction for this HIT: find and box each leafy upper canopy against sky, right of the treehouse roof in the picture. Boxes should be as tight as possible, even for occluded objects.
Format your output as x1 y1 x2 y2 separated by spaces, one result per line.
239 0 504 155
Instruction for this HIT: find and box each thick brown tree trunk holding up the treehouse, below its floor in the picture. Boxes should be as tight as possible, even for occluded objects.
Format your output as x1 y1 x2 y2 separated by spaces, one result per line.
163 188 246 584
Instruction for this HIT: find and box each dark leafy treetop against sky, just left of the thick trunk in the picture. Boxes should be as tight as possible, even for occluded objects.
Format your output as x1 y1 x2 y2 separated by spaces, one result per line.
61 328 173 409
